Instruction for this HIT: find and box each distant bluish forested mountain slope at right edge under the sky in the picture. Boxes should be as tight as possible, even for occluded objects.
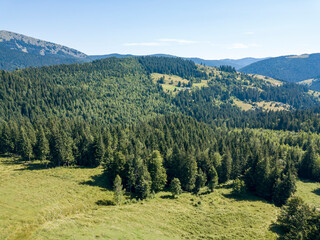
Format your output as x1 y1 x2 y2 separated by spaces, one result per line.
240 53 320 82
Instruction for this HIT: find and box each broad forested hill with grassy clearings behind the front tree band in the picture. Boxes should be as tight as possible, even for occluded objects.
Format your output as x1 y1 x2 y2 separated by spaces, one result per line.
0 57 318 123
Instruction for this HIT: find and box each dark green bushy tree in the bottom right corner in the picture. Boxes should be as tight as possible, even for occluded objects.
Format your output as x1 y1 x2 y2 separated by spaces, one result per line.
278 197 320 240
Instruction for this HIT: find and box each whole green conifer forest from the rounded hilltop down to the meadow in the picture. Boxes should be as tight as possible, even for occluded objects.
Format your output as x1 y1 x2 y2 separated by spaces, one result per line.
0 57 320 239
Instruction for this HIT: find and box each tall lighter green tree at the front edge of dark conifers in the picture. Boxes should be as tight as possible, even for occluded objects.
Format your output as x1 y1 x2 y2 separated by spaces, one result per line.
148 150 167 192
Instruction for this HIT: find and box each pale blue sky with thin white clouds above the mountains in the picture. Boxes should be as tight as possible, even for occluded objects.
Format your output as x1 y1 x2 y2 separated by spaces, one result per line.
0 0 320 59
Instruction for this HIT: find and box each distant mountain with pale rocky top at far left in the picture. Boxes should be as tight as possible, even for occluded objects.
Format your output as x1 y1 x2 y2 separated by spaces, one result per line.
0 31 89 70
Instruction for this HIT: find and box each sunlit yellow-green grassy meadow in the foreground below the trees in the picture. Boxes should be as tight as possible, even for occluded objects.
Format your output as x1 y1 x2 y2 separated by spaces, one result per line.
0 158 320 239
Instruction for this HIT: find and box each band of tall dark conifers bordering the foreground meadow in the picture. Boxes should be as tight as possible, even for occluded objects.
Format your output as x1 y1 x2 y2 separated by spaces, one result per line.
0 115 320 205
